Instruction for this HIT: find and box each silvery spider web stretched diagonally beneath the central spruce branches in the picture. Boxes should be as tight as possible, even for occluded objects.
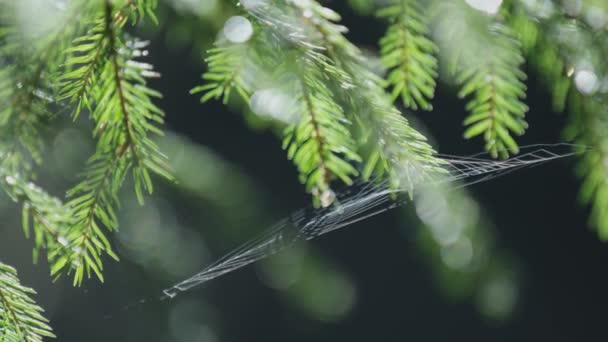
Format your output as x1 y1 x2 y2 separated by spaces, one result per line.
161 143 585 299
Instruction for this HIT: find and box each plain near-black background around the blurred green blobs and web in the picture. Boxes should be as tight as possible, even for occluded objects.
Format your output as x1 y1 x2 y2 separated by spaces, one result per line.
0 2 608 342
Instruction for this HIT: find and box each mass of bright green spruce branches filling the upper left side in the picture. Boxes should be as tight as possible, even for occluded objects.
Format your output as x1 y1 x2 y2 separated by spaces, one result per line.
0 0 171 292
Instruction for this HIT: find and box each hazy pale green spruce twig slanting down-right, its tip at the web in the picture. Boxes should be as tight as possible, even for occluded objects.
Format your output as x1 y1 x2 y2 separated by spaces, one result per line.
284 2 445 192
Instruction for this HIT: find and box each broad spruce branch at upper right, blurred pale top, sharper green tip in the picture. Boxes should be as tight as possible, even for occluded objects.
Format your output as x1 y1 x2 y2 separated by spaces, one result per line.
437 3 528 158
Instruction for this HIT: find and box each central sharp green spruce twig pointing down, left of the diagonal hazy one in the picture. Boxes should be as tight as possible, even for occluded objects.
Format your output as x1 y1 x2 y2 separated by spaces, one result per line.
193 3 361 205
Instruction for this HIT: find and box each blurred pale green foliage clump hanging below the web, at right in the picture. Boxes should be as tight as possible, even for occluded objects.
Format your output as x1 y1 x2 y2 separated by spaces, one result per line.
415 186 520 320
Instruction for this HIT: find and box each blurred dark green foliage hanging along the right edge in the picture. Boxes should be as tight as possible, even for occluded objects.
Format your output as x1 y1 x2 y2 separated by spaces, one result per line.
509 1 608 240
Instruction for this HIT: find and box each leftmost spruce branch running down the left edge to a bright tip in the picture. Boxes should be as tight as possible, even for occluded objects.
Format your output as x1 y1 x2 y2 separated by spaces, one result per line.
0 2 94 282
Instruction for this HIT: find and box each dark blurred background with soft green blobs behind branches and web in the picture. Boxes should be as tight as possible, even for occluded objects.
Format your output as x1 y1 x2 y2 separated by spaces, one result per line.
0 0 608 342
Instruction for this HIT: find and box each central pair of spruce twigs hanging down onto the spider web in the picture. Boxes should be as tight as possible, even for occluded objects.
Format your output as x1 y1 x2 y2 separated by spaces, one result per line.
193 2 442 200
